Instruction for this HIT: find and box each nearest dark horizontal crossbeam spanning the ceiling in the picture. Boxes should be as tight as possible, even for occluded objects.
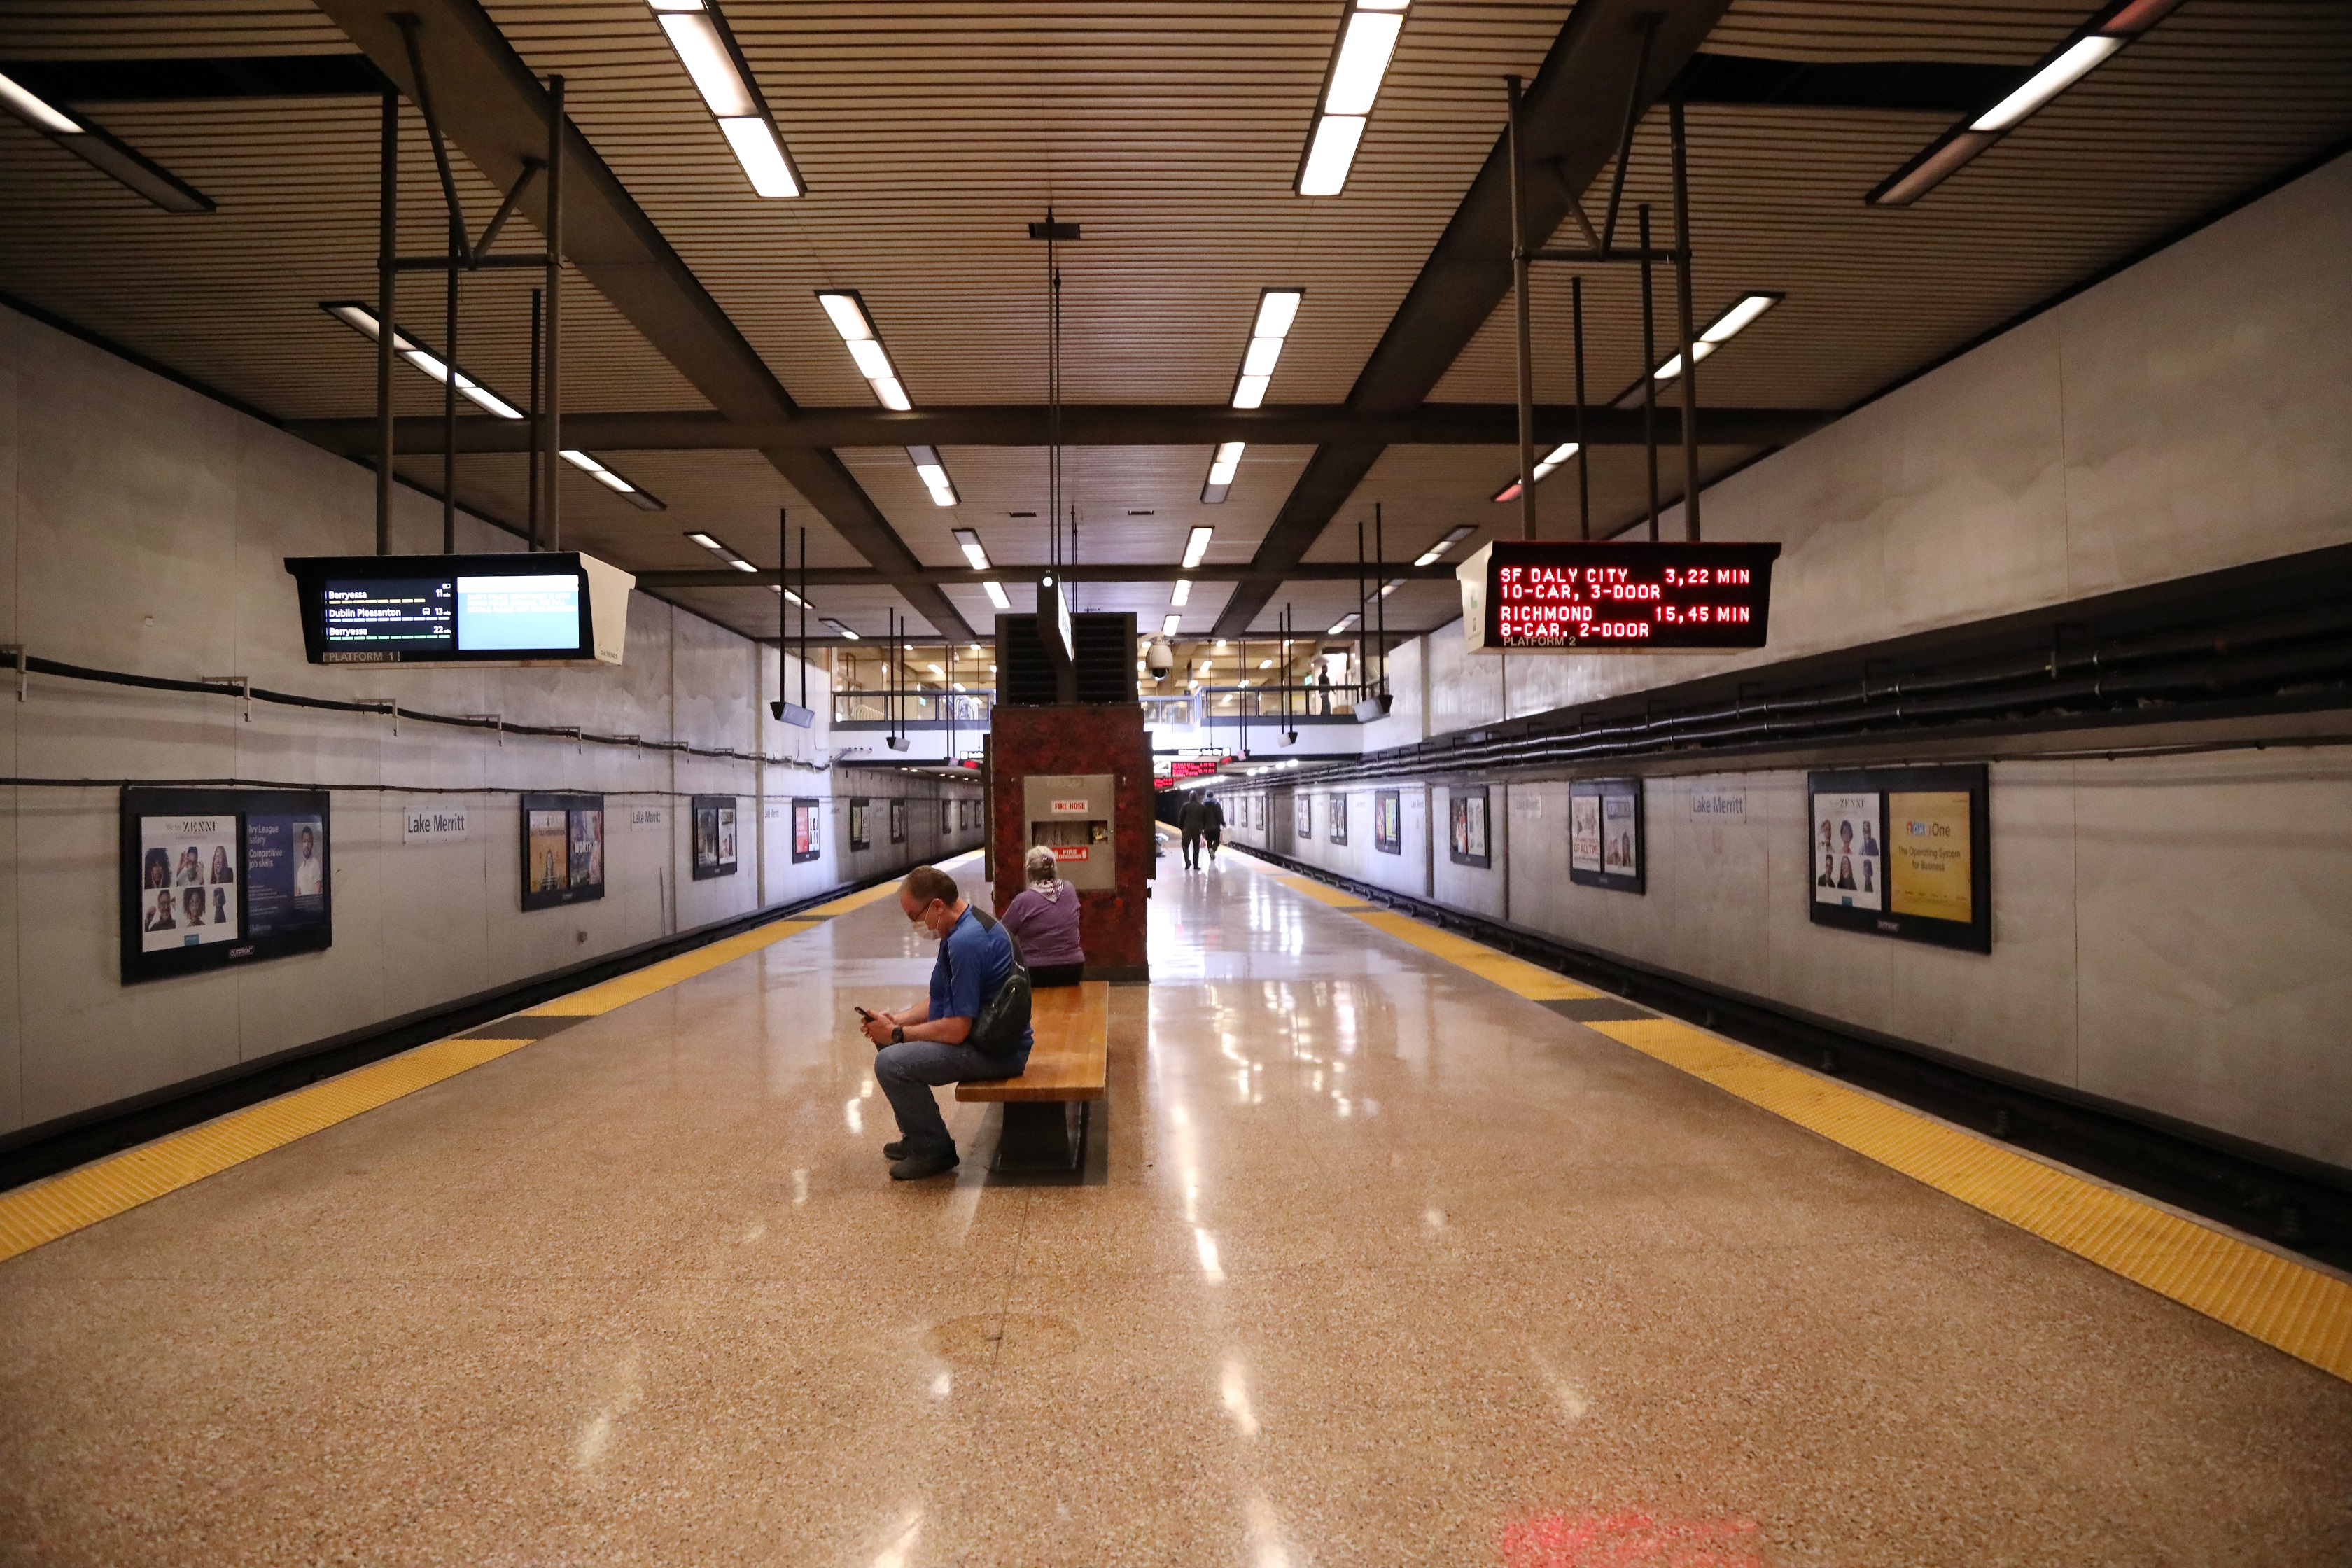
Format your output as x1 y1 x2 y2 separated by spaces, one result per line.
287 402 1837 456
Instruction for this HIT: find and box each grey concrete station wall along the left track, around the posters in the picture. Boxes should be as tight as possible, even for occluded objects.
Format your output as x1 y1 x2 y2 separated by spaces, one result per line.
0 310 979 1140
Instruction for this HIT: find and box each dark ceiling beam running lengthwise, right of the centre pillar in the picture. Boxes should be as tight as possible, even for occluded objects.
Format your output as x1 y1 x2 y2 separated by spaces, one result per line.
1216 0 1731 637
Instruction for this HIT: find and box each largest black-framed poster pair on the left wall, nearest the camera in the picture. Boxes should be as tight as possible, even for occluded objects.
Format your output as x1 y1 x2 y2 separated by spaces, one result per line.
118 788 334 985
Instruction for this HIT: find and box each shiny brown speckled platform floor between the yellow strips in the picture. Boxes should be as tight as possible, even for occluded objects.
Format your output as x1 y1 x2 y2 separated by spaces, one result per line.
0 853 2352 1568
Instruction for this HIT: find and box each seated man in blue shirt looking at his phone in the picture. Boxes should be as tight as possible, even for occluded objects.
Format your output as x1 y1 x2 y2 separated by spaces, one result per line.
858 865 1035 1182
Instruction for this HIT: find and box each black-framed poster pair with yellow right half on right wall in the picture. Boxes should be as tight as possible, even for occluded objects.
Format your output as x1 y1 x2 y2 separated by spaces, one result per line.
1804 764 1992 952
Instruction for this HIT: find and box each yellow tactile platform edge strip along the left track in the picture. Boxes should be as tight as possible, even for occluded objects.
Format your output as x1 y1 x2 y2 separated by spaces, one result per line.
0 919 818 1262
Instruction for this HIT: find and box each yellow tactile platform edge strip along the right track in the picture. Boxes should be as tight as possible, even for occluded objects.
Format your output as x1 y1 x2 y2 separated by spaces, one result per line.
1282 877 2352 1380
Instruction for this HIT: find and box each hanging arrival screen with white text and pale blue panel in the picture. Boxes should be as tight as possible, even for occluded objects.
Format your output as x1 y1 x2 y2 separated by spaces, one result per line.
287 550 635 665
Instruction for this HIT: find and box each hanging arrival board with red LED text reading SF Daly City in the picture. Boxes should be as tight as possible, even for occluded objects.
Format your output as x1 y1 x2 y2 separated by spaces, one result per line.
1456 538 1781 654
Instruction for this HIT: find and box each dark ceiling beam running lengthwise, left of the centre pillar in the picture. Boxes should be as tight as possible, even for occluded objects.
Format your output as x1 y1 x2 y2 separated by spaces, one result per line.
320 0 972 637
